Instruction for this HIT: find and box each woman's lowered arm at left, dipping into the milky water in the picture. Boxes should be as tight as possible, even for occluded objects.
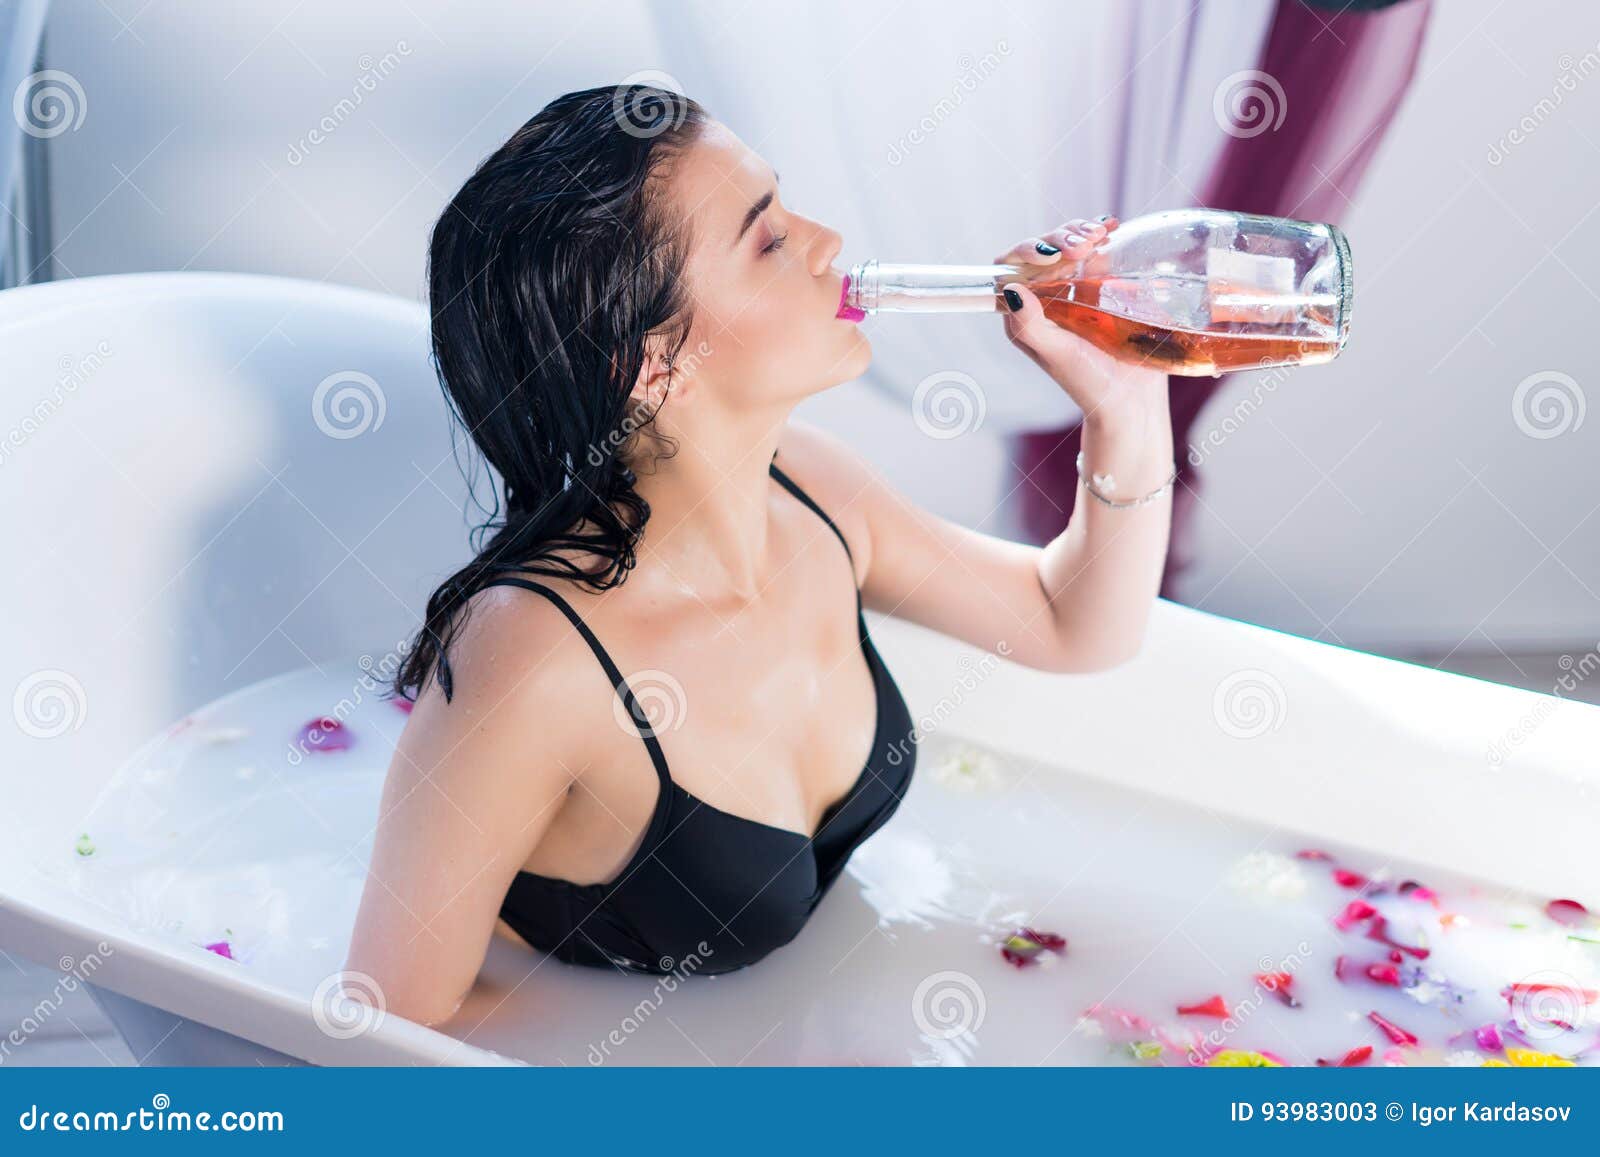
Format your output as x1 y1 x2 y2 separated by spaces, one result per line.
344 589 578 1024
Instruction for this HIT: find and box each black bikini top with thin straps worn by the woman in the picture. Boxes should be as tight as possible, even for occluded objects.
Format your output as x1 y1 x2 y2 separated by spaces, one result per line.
488 454 917 975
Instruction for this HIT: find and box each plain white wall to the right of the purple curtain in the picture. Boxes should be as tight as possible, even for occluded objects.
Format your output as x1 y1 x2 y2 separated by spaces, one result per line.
1186 0 1600 651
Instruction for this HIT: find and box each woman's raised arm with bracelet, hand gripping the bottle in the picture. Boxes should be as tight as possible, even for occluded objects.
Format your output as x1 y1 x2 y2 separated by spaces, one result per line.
784 221 1173 672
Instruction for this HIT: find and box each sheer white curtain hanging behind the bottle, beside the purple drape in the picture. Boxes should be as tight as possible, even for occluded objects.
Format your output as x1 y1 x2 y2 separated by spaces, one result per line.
651 0 1274 430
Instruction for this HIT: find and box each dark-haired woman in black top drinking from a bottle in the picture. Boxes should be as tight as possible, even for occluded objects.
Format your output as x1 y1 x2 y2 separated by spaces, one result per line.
347 86 1173 1024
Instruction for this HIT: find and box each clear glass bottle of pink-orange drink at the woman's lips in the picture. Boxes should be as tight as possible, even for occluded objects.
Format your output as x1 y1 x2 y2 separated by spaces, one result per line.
842 208 1352 376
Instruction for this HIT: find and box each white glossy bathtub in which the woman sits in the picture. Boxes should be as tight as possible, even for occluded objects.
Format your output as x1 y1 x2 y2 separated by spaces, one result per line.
0 274 1600 1064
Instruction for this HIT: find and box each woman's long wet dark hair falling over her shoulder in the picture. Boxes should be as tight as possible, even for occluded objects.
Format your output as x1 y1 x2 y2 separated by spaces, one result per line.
394 85 709 703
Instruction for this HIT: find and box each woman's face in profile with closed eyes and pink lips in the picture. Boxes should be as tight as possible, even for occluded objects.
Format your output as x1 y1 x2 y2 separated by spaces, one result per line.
667 122 872 408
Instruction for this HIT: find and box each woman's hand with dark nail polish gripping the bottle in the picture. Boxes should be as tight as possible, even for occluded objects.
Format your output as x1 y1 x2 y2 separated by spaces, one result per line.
995 214 1166 421
